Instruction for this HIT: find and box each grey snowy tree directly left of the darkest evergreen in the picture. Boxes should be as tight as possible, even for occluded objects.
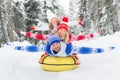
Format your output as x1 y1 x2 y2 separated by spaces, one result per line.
12 0 27 31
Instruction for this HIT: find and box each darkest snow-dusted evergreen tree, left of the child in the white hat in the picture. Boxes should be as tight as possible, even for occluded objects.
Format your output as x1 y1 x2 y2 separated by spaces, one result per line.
24 0 41 31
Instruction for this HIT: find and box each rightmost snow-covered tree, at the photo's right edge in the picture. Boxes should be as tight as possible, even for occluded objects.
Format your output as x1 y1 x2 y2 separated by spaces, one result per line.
100 0 120 35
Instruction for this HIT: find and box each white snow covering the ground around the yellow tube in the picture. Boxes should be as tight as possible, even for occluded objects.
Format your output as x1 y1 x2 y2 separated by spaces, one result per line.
0 32 120 80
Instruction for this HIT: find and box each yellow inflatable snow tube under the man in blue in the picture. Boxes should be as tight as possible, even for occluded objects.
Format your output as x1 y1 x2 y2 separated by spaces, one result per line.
39 54 80 72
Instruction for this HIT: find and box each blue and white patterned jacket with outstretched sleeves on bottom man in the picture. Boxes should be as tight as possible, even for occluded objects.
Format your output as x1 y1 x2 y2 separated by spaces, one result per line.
6 42 115 56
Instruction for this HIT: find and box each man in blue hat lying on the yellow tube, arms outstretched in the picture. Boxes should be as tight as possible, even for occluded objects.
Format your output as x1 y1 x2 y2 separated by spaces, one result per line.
9 35 115 56
